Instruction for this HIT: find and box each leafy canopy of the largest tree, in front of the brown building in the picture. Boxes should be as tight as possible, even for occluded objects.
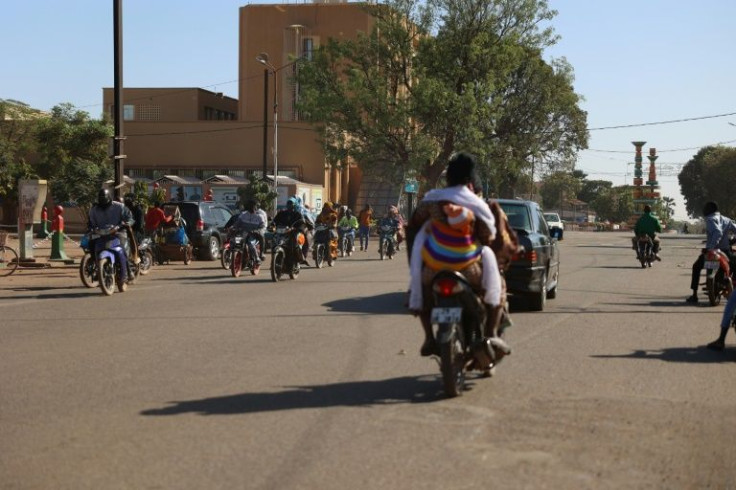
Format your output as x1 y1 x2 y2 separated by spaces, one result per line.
298 0 587 195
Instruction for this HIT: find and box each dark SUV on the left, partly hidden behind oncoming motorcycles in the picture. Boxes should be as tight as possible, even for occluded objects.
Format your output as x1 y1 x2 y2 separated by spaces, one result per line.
166 201 233 260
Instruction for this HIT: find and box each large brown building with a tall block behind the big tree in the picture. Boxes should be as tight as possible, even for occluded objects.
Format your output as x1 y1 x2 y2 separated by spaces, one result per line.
103 2 373 212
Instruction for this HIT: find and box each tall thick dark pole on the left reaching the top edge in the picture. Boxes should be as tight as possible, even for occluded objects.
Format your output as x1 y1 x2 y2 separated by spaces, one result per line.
112 0 125 201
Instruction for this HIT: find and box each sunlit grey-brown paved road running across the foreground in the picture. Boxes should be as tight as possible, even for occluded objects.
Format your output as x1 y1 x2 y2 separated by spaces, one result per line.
0 232 736 489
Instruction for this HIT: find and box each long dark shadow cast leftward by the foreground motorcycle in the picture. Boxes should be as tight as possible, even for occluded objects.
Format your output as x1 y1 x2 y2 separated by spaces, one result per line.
140 376 443 416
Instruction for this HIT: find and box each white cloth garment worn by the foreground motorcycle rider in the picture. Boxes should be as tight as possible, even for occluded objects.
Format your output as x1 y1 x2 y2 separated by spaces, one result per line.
409 185 501 311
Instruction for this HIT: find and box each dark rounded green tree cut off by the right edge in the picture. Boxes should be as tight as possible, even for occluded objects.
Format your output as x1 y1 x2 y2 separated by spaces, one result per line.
678 146 736 217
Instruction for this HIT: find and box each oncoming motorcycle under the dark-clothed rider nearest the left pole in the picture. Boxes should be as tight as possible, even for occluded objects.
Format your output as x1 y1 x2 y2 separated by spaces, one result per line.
89 226 128 296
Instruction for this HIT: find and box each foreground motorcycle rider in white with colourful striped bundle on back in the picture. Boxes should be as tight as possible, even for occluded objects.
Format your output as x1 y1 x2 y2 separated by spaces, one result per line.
406 153 501 356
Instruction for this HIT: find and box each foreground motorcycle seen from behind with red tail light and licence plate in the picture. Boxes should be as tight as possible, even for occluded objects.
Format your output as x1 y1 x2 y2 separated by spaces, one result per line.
430 270 511 397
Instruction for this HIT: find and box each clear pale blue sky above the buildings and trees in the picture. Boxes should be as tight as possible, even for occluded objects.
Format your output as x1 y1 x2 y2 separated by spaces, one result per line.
0 0 736 219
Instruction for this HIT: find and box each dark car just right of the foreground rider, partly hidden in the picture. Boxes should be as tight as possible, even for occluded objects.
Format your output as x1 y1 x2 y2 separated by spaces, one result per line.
498 199 560 311
